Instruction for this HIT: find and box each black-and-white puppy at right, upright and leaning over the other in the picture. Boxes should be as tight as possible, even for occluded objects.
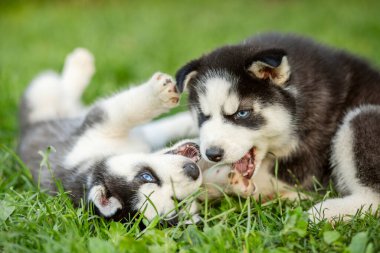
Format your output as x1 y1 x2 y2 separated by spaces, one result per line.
176 34 380 219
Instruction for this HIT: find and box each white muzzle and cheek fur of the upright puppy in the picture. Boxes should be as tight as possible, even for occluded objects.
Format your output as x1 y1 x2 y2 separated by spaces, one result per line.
200 101 298 163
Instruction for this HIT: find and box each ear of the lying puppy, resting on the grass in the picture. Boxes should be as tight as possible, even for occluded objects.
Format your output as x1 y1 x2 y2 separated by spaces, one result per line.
88 185 122 218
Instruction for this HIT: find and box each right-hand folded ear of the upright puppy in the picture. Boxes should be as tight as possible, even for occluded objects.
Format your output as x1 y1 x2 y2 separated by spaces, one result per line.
247 49 291 86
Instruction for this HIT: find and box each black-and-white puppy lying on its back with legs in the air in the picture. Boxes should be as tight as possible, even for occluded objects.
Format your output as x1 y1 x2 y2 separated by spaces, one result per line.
19 49 202 221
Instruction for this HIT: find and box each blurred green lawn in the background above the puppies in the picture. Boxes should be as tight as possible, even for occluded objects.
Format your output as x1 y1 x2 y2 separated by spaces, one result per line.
0 0 380 147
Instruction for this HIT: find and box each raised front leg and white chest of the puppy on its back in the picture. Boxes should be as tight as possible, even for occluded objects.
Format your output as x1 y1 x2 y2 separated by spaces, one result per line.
66 73 179 166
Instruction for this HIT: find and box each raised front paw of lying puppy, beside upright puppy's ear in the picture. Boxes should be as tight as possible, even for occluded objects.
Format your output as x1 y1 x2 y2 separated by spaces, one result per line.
150 72 180 108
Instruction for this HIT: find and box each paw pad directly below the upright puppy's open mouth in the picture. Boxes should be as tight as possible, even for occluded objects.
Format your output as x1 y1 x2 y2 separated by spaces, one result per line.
227 171 256 198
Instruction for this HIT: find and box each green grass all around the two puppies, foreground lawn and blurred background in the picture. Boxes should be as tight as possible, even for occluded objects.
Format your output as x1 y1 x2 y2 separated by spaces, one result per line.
0 0 380 252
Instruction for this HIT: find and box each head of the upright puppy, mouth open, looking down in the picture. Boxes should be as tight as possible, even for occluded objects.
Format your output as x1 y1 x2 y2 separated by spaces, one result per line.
176 44 296 177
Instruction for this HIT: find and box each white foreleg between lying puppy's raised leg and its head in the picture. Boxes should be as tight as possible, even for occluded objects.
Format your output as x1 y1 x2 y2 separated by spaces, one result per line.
133 112 198 150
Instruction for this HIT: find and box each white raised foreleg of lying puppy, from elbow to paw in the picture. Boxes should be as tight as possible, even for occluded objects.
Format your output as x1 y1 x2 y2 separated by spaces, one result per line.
84 73 179 137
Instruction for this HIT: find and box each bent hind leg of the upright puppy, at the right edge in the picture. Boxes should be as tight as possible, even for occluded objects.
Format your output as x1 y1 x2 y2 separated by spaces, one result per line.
309 106 380 221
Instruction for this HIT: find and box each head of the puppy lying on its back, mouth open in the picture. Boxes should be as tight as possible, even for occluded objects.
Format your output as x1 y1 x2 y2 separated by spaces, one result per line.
87 146 202 223
